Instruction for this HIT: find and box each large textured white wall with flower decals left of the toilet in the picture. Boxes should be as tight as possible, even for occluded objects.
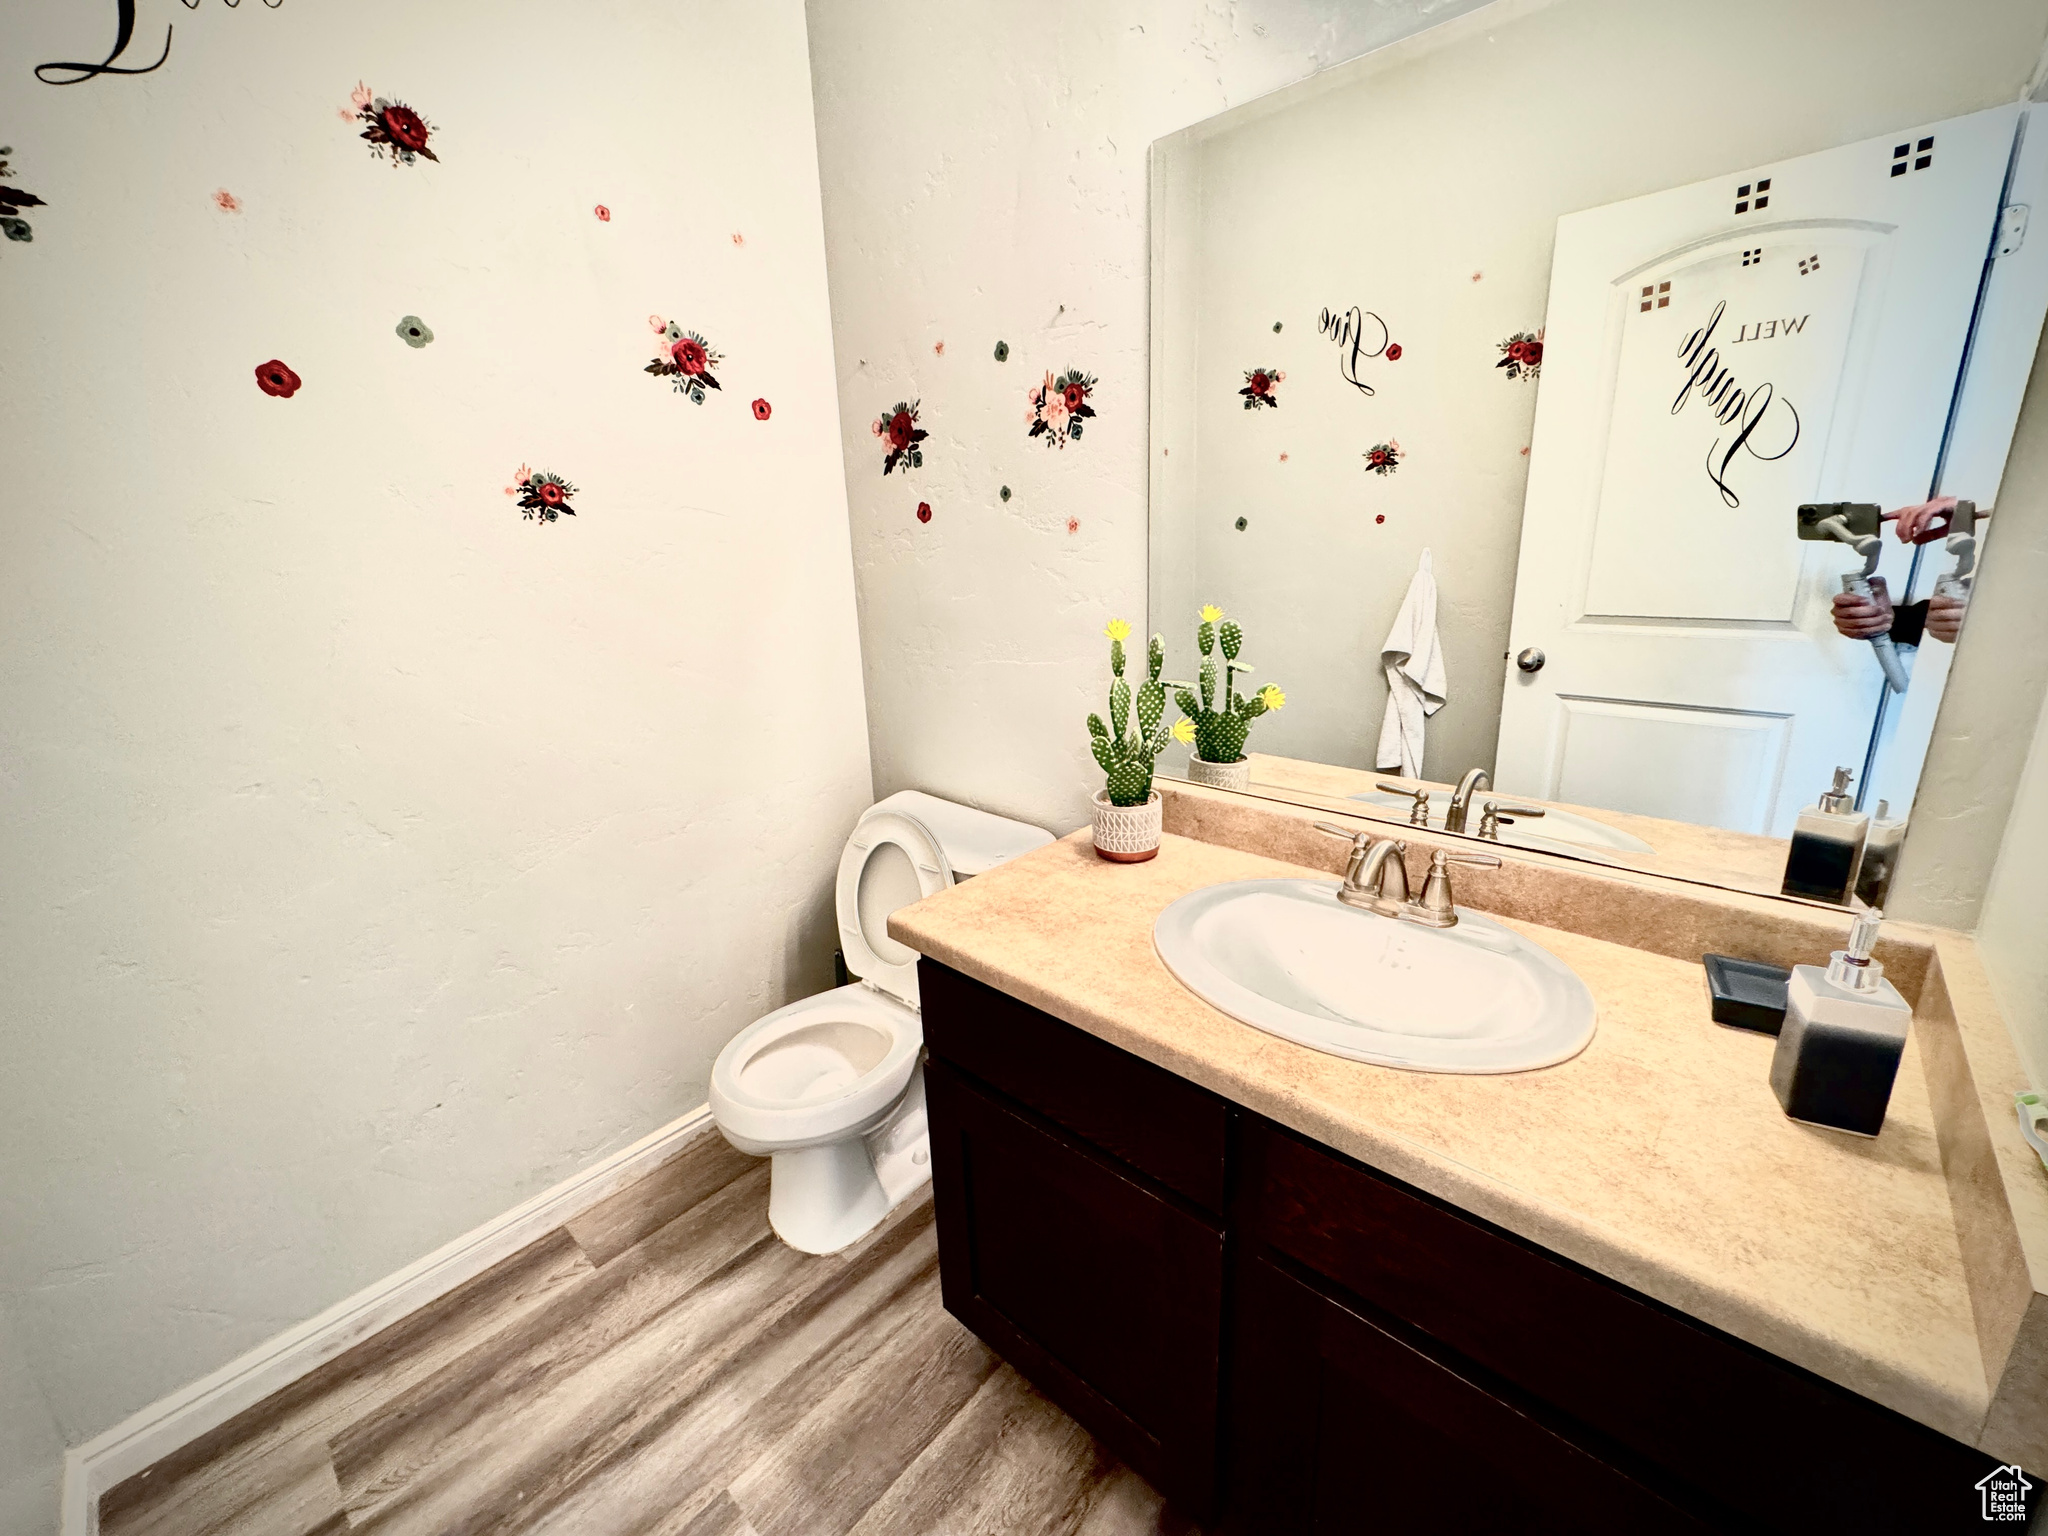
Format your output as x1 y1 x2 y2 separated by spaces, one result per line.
0 0 870 1534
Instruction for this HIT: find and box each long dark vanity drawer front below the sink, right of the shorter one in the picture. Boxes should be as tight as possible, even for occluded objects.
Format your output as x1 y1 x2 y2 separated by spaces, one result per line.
1237 1116 1997 1534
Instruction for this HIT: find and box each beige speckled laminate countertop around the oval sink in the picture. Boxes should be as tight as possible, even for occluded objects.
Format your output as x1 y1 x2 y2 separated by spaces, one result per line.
889 829 1989 1442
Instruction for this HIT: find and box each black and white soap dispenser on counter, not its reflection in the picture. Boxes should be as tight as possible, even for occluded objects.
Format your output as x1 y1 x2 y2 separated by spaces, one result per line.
1772 911 1913 1137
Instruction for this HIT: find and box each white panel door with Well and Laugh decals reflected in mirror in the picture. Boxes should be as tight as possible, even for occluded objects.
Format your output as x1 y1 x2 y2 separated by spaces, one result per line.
1493 106 2019 836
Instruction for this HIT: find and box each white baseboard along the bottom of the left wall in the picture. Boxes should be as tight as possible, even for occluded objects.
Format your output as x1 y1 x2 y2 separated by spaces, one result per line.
61 1104 711 1536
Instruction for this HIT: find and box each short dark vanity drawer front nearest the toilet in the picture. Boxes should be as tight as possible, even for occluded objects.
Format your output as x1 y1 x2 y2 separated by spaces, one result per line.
918 961 1231 1214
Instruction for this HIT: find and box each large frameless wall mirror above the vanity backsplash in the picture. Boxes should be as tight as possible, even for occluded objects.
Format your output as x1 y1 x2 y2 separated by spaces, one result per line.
1151 0 2048 905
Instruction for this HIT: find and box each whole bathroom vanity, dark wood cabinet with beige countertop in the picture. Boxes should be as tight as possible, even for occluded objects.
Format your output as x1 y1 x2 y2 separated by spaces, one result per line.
893 806 2048 1532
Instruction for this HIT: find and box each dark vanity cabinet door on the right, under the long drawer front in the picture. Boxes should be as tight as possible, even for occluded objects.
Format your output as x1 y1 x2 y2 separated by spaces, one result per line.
1229 1255 1712 1536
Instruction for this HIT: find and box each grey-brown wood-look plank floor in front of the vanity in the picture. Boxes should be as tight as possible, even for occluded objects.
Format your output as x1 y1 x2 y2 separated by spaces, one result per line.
100 1128 1188 1536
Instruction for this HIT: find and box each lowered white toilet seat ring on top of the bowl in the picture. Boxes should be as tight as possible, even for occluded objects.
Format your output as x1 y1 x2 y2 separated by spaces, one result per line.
711 983 924 1157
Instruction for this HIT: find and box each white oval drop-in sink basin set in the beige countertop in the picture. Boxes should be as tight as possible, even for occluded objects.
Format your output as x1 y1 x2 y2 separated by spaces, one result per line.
1153 881 1595 1073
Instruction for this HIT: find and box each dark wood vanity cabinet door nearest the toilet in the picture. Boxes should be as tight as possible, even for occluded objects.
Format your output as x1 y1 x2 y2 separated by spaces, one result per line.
926 1057 1223 1520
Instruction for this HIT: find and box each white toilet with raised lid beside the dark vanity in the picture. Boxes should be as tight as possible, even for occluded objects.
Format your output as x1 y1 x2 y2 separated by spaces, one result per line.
711 788 1053 1253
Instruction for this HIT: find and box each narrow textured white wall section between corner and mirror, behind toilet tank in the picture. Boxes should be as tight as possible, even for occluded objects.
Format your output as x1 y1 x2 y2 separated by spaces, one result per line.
809 0 1470 831
